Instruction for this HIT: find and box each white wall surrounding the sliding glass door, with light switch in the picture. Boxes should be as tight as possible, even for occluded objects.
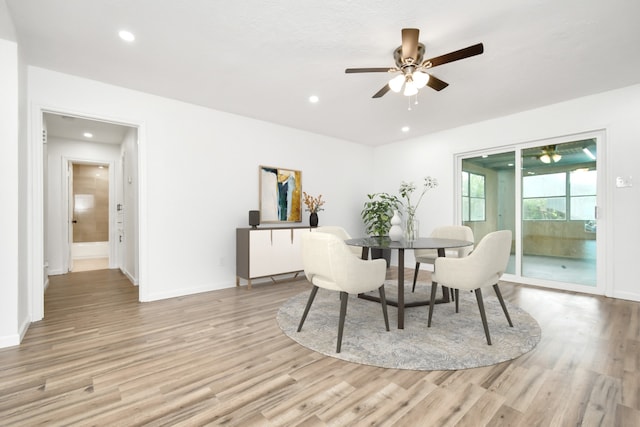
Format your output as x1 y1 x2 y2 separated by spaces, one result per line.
373 85 640 301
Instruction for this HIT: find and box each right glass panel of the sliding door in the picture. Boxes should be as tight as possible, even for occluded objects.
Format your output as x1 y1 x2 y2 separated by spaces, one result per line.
521 139 598 286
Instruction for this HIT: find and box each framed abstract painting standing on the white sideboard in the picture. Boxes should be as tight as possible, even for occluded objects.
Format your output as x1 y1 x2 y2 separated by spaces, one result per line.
260 166 302 223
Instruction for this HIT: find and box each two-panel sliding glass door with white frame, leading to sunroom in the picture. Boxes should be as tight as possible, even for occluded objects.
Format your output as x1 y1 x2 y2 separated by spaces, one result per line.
458 134 604 293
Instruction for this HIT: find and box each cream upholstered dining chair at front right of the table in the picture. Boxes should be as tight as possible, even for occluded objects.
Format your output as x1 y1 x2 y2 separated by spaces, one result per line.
427 230 513 345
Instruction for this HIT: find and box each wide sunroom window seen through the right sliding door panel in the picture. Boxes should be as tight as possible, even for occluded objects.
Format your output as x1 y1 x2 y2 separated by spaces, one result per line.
522 170 597 221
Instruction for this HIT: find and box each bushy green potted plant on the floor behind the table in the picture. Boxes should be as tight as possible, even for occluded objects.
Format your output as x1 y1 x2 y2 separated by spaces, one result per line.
360 193 400 267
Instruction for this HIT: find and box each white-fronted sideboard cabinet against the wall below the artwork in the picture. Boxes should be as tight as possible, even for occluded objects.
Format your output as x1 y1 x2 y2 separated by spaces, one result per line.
236 227 311 289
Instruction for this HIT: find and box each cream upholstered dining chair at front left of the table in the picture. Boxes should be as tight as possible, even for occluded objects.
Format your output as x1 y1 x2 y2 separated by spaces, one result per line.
298 232 389 353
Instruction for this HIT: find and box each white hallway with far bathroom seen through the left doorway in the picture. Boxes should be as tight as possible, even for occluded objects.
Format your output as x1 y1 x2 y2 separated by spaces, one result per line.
43 112 138 285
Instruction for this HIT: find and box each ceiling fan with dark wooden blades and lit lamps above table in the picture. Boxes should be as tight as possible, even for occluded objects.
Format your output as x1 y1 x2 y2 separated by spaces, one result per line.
344 28 484 98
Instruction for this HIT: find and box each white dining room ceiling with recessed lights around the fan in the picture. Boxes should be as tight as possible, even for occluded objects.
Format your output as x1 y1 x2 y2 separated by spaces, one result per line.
6 0 640 146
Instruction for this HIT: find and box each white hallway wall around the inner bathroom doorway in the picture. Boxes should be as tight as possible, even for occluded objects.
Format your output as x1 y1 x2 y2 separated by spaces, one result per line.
46 137 120 275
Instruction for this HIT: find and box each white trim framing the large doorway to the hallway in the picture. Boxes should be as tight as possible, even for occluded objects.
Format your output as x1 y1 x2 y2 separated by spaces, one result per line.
27 103 149 322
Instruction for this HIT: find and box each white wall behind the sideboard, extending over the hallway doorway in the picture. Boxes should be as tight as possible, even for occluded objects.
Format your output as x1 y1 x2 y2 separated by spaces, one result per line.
29 67 374 301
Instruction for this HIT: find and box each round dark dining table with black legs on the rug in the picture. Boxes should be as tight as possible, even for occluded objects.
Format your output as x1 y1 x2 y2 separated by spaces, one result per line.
345 236 473 329
